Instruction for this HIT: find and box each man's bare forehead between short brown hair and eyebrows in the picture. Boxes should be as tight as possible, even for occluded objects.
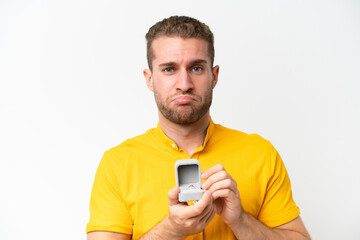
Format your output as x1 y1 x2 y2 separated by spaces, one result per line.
152 36 210 65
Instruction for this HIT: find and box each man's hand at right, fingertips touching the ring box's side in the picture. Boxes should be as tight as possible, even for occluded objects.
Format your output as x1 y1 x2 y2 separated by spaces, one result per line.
201 164 243 226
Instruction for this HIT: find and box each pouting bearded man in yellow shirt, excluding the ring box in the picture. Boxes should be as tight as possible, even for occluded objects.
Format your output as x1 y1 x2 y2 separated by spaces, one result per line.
87 16 310 240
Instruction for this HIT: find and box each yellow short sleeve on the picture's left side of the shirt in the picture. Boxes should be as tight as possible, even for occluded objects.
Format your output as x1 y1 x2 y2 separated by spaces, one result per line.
86 153 133 234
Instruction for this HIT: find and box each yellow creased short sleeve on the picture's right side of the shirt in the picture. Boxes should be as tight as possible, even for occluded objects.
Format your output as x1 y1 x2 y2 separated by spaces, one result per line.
258 143 300 227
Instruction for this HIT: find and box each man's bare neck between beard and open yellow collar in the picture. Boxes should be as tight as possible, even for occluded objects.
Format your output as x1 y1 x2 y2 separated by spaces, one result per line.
159 112 210 156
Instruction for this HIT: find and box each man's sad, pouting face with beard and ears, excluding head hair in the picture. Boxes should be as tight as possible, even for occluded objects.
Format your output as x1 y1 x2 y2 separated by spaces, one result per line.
144 37 219 124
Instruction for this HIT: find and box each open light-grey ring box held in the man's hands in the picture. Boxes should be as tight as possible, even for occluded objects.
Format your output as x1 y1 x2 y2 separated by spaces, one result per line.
175 159 204 202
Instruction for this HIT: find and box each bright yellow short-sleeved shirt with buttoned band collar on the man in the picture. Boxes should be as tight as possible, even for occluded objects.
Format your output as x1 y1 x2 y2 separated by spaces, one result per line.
86 121 299 240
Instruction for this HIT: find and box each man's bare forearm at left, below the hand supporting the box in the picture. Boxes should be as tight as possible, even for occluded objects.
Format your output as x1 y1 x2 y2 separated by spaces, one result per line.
139 216 183 240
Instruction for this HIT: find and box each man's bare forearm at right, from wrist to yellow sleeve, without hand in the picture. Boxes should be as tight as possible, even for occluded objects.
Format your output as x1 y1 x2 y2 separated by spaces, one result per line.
230 211 310 240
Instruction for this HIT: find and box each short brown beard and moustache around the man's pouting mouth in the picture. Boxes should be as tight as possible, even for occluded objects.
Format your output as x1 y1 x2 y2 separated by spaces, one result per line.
154 86 213 125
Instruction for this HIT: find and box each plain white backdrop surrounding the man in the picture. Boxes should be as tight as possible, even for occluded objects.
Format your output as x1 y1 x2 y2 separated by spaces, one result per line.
0 0 360 240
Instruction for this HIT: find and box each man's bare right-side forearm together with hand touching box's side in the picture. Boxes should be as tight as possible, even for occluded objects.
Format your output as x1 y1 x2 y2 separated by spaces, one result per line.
202 164 310 240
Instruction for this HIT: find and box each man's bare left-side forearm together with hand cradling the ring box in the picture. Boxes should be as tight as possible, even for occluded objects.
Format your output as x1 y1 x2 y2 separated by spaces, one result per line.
140 187 215 240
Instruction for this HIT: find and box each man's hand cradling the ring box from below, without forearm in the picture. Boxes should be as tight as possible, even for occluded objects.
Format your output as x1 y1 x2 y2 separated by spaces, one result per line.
167 186 215 239
